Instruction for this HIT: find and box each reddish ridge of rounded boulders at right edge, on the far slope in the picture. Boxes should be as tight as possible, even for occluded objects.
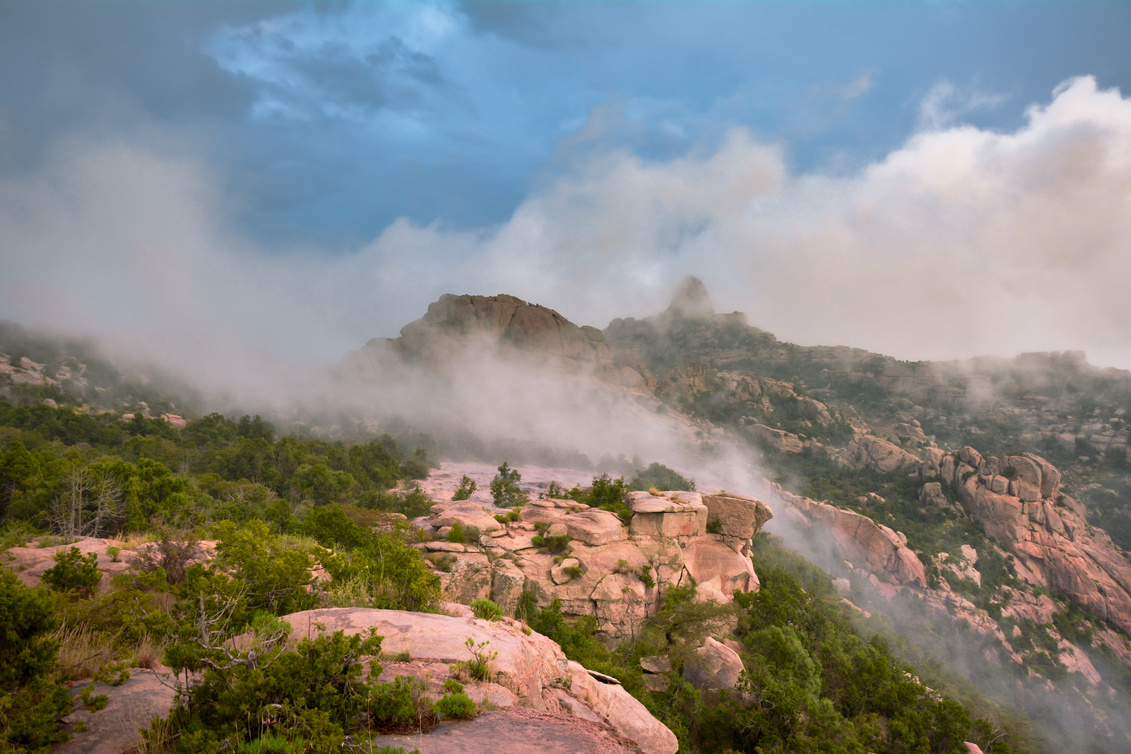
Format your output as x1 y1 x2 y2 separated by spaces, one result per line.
921 448 1131 633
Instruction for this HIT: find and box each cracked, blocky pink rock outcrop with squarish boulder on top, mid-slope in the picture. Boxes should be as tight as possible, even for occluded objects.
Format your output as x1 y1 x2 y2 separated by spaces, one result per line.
414 492 772 639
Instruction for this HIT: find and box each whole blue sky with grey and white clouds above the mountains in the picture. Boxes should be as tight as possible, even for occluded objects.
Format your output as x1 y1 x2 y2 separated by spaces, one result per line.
0 0 1131 369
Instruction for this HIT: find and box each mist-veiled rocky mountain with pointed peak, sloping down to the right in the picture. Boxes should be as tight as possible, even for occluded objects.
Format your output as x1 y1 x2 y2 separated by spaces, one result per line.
341 278 1131 750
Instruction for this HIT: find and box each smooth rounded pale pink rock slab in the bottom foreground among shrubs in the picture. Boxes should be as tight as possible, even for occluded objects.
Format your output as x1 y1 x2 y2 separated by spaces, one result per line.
285 608 679 754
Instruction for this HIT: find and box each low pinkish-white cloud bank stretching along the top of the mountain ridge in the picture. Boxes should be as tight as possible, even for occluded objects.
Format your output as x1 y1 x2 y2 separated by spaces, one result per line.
0 78 1131 397
